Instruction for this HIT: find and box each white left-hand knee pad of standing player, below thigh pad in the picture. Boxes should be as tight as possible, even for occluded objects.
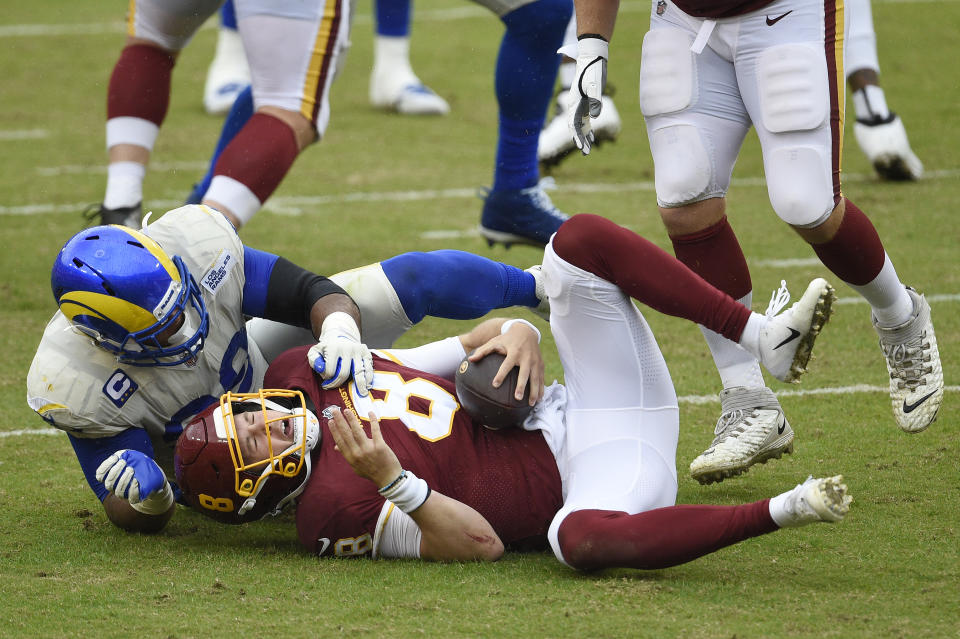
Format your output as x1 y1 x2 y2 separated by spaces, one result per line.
649 124 713 207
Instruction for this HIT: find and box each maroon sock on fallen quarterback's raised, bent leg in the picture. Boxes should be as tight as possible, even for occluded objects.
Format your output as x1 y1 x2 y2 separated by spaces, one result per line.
553 214 750 342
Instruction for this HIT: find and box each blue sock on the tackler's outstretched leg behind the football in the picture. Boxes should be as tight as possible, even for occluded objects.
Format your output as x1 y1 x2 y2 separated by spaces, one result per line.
381 250 540 324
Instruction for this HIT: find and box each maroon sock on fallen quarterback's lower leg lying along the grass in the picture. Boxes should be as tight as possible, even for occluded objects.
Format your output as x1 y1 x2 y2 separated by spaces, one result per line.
558 499 778 570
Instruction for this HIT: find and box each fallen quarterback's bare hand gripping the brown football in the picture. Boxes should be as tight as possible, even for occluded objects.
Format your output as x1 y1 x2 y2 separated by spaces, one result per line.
469 320 546 406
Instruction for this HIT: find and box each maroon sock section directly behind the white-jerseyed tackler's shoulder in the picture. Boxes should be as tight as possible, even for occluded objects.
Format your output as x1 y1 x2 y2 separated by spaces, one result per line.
213 113 300 202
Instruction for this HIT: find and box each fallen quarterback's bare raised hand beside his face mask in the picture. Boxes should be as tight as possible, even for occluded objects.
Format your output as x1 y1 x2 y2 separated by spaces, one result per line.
328 406 403 488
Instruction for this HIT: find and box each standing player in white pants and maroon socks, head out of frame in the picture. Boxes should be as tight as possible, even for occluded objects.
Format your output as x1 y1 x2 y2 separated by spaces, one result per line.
568 0 943 483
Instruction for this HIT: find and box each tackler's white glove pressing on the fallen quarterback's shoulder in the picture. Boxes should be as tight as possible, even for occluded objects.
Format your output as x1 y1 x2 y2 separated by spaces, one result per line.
307 311 373 397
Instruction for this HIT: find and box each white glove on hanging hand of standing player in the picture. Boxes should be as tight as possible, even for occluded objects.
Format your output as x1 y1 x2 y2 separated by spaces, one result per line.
567 36 610 155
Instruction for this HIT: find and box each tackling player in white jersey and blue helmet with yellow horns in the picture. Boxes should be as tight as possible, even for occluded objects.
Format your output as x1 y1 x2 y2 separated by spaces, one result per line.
27 205 540 531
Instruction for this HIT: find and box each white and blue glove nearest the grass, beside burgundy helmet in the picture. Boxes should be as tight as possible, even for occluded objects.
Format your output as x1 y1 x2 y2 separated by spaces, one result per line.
96 449 173 515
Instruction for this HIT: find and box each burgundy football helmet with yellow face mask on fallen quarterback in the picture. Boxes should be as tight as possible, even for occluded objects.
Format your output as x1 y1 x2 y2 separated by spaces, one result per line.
173 390 320 524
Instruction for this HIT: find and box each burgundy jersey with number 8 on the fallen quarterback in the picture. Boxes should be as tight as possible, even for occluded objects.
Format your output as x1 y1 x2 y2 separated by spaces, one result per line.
264 346 563 556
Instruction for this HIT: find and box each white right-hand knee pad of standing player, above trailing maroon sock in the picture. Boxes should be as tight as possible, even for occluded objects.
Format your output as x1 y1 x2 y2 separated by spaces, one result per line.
766 146 833 227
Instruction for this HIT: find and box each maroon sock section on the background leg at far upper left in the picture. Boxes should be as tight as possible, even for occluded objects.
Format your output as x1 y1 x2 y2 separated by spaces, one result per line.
107 44 174 126
